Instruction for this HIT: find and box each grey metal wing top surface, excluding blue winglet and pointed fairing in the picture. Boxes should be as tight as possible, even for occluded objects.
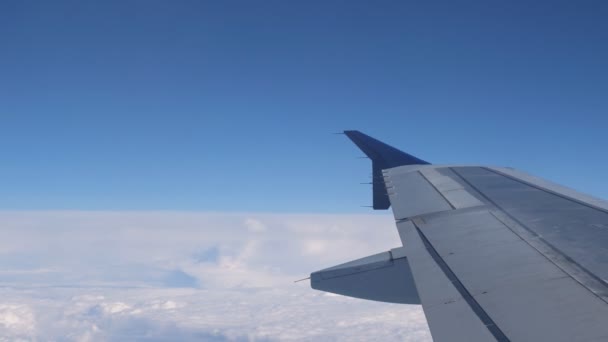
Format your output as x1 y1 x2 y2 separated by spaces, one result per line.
384 165 608 341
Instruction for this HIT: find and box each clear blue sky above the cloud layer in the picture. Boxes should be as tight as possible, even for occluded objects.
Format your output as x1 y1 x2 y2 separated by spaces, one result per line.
0 0 608 212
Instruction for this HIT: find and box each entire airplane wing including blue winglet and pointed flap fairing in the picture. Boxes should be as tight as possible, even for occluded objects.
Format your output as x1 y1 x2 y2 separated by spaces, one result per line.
311 131 608 342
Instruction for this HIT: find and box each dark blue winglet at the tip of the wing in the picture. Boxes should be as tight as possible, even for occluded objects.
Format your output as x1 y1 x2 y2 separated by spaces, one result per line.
344 131 430 210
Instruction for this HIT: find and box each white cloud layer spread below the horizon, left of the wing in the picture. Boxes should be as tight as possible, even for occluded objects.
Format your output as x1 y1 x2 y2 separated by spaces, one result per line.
0 212 430 341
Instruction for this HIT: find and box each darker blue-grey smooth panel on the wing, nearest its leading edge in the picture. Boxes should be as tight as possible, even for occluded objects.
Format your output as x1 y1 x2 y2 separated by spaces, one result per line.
454 167 608 281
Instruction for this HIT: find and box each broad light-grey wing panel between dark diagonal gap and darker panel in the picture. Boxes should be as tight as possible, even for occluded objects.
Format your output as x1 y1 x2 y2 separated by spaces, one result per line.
412 209 608 341
